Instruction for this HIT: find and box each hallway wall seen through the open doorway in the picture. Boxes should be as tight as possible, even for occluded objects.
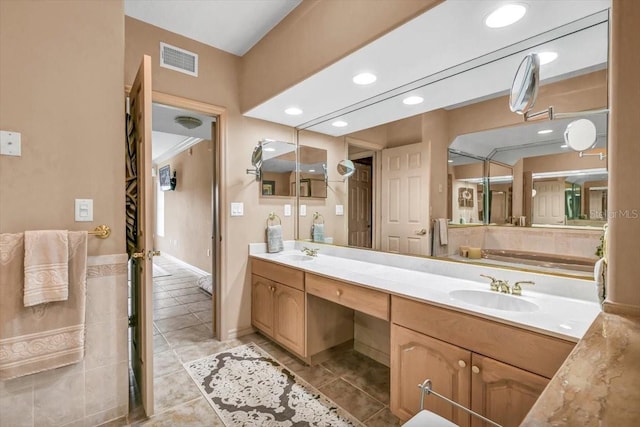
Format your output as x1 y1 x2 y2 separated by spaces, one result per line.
156 141 213 273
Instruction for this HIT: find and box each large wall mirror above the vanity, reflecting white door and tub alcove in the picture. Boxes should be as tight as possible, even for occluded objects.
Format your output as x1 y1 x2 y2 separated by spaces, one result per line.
298 10 609 277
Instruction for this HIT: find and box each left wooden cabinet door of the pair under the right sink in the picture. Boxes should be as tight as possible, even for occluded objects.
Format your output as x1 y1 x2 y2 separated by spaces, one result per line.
391 325 471 427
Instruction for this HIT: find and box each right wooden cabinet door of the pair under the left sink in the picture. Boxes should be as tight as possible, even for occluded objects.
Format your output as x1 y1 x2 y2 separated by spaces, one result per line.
274 283 306 357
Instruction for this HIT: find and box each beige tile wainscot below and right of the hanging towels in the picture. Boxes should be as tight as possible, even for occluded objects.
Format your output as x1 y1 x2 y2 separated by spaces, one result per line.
0 254 129 427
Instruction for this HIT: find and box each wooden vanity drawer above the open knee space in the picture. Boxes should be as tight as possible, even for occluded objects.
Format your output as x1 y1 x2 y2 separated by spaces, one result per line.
305 273 389 320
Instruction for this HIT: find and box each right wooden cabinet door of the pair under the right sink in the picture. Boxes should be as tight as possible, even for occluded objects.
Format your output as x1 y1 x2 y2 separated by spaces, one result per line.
471 354 549 427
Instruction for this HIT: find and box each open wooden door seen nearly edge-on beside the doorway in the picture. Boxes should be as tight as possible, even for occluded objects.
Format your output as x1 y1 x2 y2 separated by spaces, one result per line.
130 55 154 417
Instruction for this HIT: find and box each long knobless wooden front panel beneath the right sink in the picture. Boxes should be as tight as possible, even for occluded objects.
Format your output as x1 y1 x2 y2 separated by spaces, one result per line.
391 296 575 378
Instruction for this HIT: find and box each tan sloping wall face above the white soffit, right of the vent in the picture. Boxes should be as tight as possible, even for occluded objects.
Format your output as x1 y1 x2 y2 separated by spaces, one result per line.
240 0 442 112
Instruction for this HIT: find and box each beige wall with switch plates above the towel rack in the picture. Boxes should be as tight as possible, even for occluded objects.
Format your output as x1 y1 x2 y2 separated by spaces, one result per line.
0 0 125 255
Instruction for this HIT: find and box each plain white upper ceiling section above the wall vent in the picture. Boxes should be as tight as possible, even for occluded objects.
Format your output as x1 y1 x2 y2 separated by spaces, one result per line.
124 0 302 56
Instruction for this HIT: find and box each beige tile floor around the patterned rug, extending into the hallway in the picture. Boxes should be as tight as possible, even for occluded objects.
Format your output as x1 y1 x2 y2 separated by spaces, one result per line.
114 257 400 427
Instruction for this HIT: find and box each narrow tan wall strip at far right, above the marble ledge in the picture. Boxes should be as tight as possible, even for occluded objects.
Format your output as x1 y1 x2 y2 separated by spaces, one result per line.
605 0 640 315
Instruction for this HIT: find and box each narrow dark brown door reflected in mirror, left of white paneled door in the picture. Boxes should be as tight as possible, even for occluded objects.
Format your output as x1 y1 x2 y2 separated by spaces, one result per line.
348 156 373 248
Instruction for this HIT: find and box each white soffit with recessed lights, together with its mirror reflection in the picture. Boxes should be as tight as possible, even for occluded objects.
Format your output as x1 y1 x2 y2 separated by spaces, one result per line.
246 0 610 136
